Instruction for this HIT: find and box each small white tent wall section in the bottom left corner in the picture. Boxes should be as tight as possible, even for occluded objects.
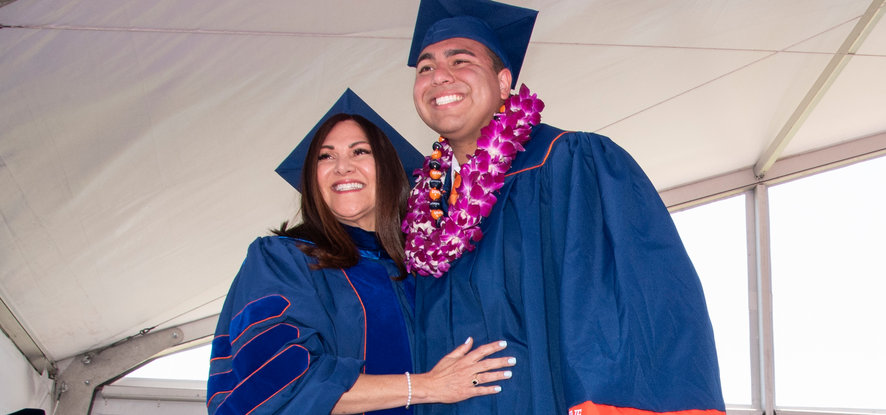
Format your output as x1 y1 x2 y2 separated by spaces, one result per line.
0 333 52 414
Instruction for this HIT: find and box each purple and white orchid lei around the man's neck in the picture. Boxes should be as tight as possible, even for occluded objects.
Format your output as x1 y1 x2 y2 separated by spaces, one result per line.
401 85 544 278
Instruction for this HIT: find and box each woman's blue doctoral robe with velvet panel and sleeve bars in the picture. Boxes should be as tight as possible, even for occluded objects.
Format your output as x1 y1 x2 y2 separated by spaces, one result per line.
207 226 415 415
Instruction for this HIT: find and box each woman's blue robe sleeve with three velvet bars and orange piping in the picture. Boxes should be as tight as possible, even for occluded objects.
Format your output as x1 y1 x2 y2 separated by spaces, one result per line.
207 237 364 414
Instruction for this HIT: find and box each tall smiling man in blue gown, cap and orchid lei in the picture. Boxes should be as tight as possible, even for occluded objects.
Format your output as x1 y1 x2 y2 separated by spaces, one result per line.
403 0 725 415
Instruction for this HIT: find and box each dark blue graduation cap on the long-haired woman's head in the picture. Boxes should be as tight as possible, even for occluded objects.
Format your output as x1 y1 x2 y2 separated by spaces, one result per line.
275 88 425 192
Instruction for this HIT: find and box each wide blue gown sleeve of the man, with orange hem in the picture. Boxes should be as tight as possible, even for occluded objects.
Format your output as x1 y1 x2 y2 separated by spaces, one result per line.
540 133 724 415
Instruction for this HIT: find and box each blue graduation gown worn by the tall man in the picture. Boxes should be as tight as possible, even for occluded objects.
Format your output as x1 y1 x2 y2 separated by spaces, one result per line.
415 124 724 415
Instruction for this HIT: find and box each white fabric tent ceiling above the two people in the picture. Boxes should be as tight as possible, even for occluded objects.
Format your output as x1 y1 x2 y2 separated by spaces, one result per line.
0 0 886 368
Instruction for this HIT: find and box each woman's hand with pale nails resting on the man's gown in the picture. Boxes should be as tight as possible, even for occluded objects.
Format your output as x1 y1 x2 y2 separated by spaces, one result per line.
412 338 517 403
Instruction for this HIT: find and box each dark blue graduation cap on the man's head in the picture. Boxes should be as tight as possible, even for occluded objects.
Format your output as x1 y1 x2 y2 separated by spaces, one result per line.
407 0 538 88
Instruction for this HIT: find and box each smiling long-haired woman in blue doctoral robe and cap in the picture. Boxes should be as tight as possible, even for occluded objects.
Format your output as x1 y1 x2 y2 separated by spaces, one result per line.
207 90 514 414
